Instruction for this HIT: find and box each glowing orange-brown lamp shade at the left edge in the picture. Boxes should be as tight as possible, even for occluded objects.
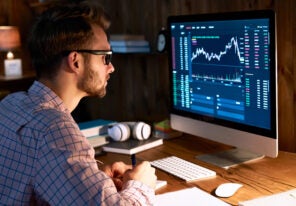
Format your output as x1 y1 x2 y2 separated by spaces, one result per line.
0 26 21 51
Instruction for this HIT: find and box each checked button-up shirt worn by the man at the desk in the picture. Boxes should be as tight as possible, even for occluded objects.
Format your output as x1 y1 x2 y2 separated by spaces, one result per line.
0 81 155 205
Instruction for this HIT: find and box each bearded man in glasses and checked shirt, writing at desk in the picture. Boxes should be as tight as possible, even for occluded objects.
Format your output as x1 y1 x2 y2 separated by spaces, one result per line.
0 2 156 205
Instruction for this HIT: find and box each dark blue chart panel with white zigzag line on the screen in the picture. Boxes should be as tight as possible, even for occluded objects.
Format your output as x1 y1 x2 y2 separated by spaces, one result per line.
190 35 244 83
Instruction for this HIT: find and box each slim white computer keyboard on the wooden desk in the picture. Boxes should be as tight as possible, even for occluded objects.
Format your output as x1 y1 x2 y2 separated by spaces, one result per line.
150 156 216 182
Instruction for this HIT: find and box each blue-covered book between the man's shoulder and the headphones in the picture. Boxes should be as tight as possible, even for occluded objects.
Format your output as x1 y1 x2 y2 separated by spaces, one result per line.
78 119 116 137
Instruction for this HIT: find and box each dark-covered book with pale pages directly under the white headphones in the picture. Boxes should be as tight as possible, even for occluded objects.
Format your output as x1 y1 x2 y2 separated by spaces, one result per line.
103 137 163 155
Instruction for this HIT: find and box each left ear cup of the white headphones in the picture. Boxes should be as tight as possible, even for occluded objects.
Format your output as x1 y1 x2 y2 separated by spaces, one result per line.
108 123 130 142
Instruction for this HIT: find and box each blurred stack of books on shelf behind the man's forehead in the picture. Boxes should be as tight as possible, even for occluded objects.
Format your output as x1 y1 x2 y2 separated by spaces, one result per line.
110 34 150 53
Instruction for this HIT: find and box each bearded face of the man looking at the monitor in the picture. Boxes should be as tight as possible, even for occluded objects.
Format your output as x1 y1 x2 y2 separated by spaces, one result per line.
78 27 114 97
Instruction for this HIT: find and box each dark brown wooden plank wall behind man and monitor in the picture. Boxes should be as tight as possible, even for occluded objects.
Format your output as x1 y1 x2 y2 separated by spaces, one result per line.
0 0 296 152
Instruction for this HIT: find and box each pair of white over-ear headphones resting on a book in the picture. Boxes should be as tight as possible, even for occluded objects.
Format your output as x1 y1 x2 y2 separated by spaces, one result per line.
108 122 151 142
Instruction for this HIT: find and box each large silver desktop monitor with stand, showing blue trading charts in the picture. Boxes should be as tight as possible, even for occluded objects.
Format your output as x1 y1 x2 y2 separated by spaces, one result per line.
167 10 278 168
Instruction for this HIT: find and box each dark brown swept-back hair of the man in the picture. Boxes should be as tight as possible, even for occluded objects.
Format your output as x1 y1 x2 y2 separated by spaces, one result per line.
28 0 110 79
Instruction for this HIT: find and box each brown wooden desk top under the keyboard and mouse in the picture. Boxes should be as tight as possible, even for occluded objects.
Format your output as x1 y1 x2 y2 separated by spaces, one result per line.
97 135 296 205
